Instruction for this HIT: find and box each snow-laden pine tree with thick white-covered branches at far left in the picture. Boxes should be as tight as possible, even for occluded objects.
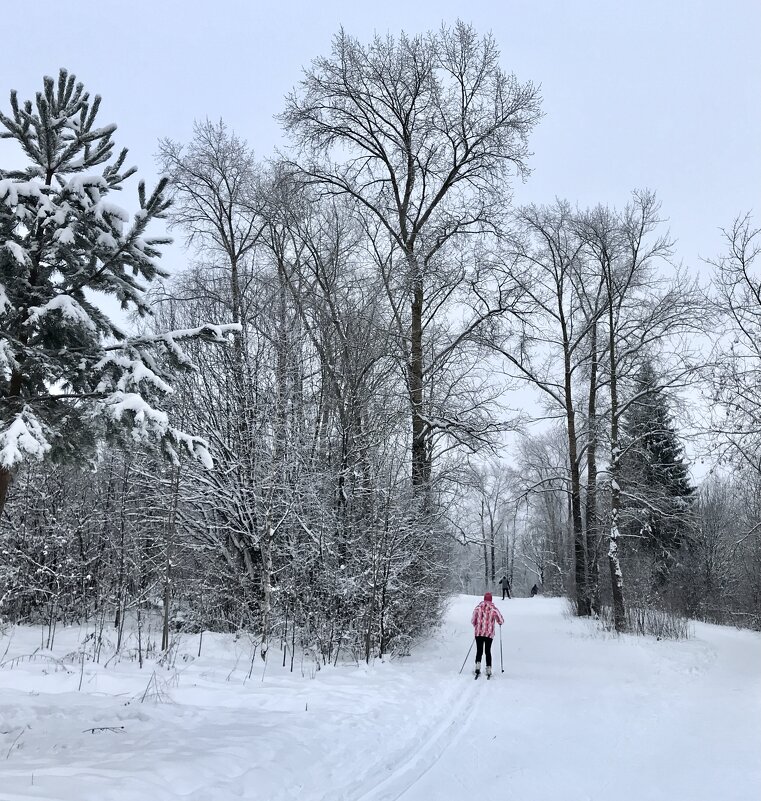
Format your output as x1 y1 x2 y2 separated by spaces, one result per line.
0 69 236 514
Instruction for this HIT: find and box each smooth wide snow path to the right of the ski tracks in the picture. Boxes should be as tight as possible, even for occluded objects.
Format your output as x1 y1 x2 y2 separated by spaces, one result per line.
366 597 761 801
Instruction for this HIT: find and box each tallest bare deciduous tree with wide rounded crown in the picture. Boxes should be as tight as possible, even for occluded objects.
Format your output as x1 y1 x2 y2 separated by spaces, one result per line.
281 23 540 488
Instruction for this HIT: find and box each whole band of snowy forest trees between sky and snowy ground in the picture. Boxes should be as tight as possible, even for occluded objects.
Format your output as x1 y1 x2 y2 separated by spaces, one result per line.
0 23 761 663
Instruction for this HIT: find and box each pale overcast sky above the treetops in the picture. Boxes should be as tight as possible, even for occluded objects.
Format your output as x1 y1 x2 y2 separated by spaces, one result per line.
0 0 761 276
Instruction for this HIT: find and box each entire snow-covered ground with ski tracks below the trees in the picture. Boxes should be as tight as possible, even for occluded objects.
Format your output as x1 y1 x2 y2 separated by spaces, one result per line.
0 596 761 801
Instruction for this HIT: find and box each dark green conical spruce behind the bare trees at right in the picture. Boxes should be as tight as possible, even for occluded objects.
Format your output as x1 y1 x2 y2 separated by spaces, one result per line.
621 361 695 584
